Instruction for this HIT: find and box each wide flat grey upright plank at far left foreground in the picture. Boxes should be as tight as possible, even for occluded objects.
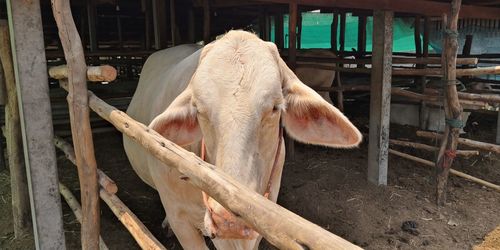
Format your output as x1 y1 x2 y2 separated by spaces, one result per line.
7 0 66 249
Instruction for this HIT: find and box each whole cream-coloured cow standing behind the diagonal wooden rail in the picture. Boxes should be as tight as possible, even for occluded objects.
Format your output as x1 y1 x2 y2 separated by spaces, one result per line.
124 30 362 249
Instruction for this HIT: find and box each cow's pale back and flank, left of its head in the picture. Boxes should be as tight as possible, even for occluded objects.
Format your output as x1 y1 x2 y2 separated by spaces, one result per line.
123 45 201 188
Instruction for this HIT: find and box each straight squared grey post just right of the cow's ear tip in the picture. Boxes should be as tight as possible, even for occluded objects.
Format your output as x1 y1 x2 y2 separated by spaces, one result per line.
368 10 394 185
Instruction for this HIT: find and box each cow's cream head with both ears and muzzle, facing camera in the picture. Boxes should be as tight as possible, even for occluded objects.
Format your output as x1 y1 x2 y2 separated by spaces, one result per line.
150 31 361 238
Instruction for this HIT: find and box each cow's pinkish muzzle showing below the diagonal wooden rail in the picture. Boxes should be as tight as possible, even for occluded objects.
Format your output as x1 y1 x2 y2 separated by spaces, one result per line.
204 198 259 240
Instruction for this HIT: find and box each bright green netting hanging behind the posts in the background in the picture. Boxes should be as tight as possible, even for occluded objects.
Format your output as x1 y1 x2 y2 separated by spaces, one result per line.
271 12 432 52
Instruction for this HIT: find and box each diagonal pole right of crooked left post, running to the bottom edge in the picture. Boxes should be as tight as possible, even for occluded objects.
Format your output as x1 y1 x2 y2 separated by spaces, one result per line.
99 189 167 250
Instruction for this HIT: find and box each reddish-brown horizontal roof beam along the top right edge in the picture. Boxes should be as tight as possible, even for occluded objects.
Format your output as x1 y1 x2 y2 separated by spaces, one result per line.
261 0 500 19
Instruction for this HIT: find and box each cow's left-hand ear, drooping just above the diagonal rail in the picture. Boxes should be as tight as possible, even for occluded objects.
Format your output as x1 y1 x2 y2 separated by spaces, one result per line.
149 88 202 146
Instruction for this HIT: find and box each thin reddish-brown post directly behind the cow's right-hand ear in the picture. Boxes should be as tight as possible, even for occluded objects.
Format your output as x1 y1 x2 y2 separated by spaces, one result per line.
286 3 297 160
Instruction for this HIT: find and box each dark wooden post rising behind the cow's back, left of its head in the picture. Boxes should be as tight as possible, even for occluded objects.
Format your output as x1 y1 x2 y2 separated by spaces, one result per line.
152 0 167 50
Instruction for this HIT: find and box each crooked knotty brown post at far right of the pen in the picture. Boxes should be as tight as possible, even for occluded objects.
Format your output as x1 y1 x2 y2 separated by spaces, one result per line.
436 0 463 206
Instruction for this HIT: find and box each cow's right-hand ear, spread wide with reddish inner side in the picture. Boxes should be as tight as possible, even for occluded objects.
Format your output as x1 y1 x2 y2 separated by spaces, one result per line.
269 44 363 148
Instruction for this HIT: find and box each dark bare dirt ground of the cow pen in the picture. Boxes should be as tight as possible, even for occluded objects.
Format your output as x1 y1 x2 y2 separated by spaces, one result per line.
0 104 500 250
